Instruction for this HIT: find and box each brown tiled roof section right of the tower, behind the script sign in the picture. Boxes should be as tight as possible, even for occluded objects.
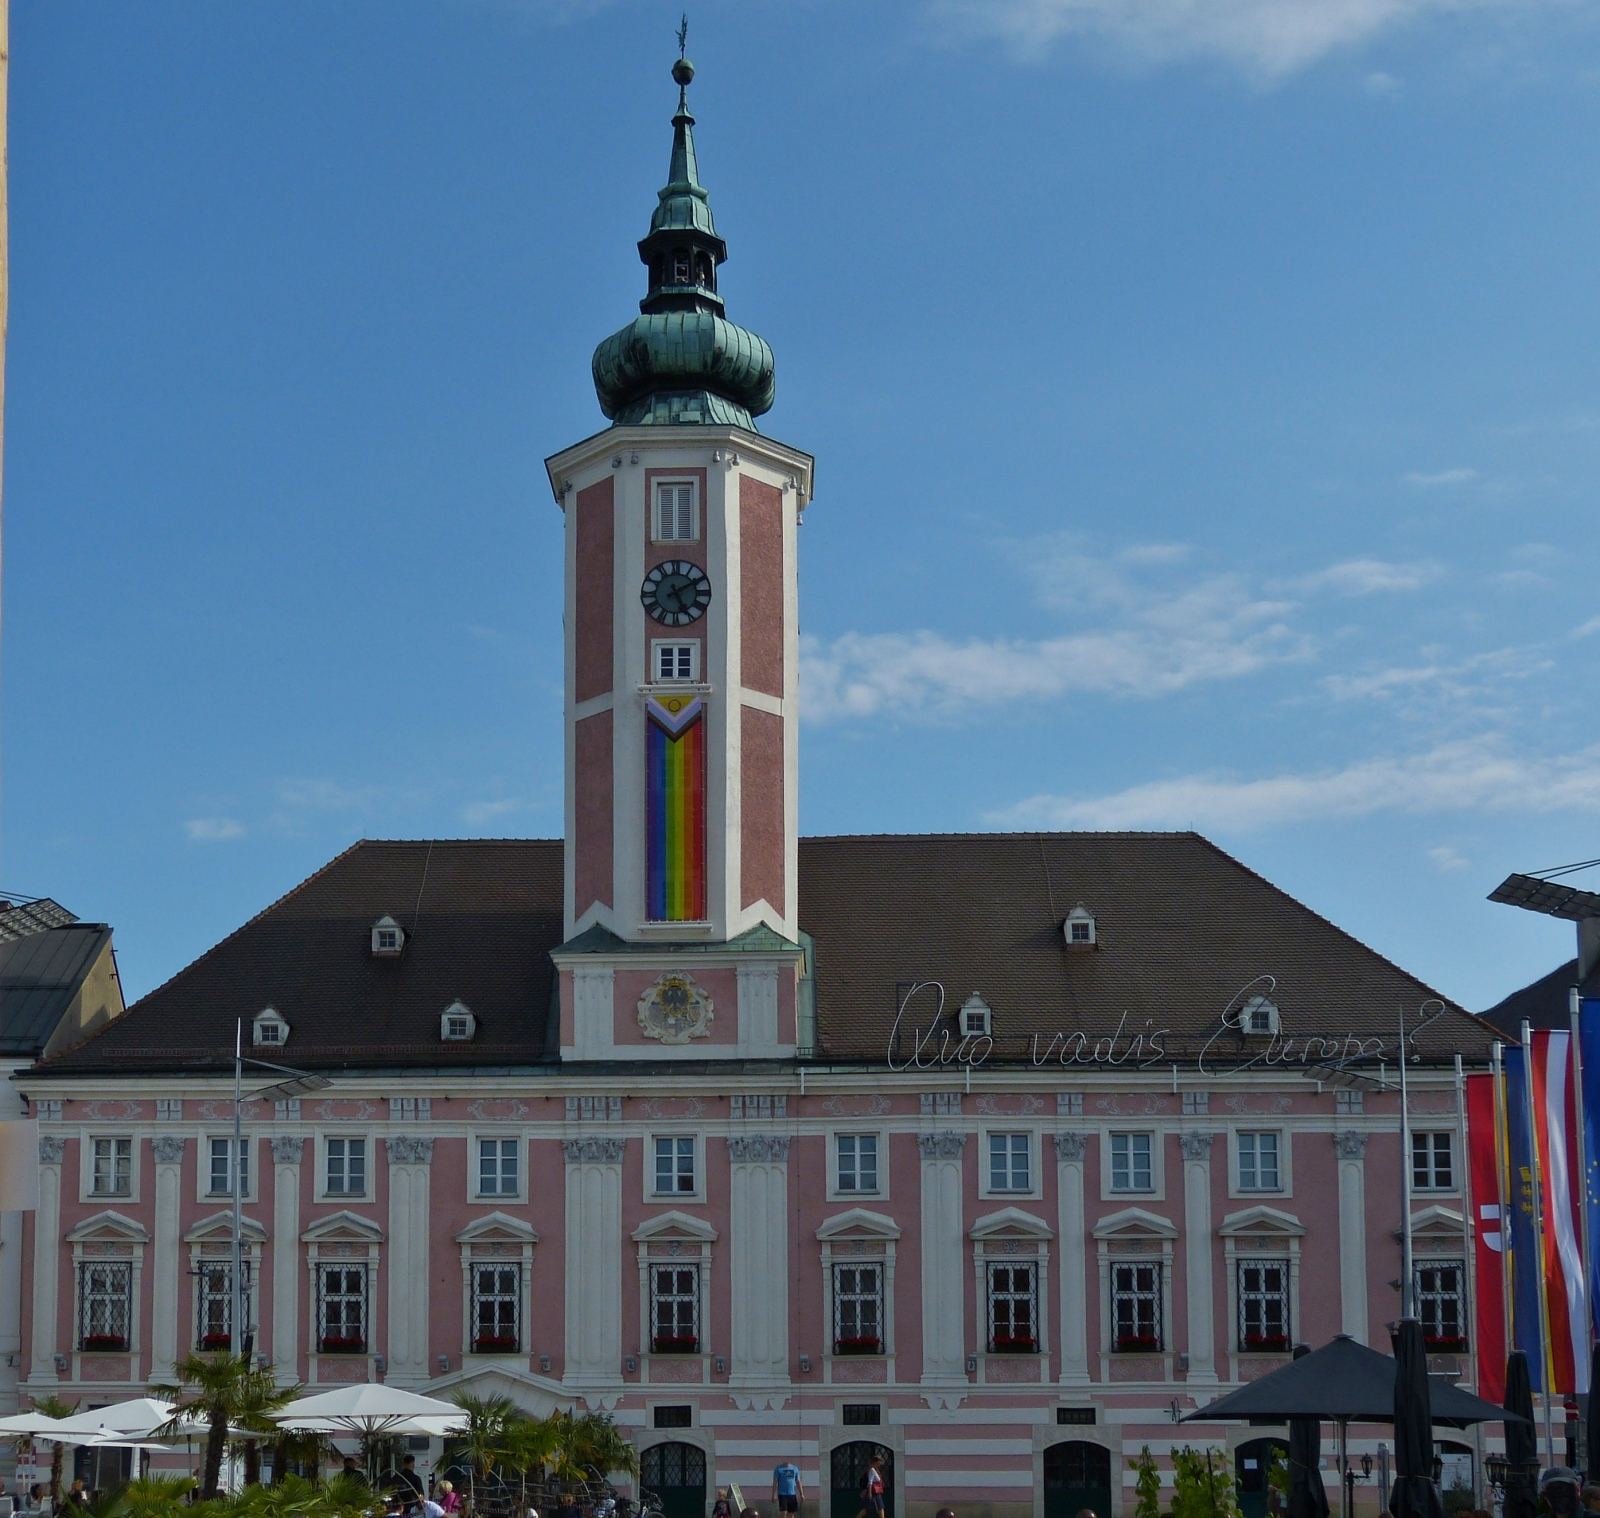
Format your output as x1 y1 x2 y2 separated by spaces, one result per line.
800 833 1493 1073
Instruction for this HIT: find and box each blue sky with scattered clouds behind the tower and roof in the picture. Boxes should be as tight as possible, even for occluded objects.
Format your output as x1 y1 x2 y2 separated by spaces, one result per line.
0 0 1600 1008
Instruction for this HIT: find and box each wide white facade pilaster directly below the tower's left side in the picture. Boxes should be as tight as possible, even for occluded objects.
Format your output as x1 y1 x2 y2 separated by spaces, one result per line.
562 1139 627 1388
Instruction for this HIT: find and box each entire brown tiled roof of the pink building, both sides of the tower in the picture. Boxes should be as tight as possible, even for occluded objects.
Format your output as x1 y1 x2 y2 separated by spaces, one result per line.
40 833 1491 1073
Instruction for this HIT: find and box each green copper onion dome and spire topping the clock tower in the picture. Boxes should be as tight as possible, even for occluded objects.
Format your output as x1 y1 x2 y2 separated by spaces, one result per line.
594 58 774 432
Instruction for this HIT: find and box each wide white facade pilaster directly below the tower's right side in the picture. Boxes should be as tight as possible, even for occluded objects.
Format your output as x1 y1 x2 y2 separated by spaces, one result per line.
728 1132 789 1387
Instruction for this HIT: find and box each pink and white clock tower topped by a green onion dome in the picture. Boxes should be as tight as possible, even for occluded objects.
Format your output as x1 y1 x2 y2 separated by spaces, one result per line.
546 58 811 1061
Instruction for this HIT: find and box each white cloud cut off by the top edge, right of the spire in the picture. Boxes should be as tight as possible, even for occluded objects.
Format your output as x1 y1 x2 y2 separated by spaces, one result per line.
934 0 1488 78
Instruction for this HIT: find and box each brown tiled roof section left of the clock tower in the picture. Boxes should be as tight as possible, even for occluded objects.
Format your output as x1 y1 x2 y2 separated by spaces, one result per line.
42 840 562 1072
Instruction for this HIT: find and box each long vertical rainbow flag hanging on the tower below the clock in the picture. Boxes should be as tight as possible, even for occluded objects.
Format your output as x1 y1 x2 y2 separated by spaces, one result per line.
645 693 706 923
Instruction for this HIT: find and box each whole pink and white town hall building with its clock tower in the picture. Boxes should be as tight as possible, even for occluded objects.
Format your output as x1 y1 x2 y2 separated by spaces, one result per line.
18 61 1491 1518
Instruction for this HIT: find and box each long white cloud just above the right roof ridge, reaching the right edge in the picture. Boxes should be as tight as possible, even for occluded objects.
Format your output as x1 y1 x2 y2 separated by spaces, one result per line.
989 737 1600 832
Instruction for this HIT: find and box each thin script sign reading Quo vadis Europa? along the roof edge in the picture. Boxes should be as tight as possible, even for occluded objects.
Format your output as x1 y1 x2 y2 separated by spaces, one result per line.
885 976 1445 1075
